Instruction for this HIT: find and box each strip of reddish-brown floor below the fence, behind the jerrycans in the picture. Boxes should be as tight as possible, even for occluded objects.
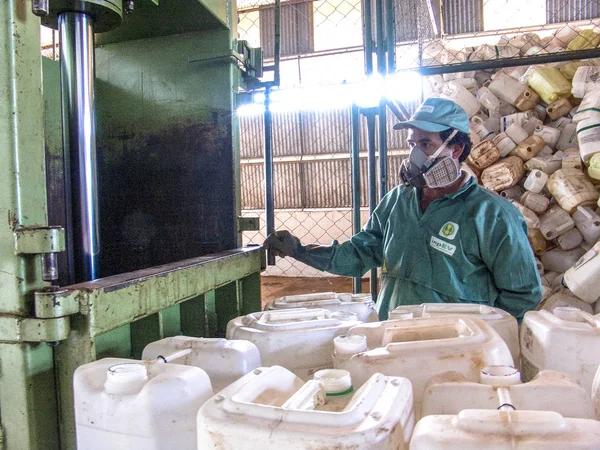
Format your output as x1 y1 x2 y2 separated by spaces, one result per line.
261 276 369 305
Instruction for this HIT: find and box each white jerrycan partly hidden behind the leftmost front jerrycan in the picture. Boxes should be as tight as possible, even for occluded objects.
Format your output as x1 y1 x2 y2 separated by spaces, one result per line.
142 336 261 392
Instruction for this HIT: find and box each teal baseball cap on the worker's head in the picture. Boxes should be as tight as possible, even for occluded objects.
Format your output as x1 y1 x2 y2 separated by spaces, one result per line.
394 98 471 134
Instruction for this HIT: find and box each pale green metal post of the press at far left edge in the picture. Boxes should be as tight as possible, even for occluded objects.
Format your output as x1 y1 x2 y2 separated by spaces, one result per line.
0 0 58 450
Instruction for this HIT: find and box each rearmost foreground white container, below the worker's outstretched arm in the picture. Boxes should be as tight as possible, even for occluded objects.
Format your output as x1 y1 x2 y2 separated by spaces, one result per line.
264 292 379 322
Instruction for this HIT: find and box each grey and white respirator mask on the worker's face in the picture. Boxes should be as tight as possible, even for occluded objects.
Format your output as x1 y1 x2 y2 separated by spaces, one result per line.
400 130 460 189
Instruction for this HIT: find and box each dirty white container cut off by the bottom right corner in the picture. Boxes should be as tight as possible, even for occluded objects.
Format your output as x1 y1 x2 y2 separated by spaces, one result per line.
410 408 600 450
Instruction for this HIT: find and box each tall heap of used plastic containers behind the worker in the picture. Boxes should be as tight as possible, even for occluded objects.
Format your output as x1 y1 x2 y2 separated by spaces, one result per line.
420 30 600 313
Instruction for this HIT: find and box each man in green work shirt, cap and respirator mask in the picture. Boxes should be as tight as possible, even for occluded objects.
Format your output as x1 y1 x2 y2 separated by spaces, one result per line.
264 98 542 322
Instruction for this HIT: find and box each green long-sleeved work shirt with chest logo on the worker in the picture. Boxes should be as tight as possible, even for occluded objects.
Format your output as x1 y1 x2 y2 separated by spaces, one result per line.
312 178 542 321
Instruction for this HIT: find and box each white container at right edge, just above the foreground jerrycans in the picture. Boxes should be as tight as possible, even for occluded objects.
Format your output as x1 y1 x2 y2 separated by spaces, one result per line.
564 242 600 303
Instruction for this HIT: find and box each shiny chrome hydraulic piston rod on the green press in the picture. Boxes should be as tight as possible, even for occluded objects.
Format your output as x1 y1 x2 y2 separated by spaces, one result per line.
58 12 100 282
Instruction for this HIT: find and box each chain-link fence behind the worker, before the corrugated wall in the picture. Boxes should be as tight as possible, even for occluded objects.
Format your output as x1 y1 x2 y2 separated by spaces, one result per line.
238 0 600 276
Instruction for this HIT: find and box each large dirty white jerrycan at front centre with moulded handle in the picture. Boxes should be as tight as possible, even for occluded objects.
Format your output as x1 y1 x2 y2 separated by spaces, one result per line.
198 366 415 450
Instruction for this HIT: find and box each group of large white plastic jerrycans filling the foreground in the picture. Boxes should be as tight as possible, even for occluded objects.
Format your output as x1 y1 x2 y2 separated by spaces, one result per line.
73 292 600 450
